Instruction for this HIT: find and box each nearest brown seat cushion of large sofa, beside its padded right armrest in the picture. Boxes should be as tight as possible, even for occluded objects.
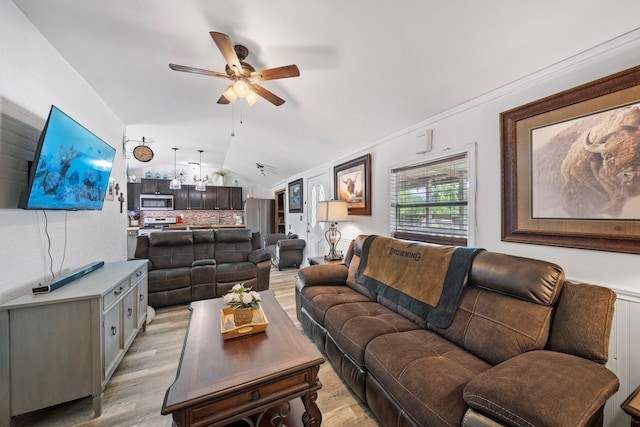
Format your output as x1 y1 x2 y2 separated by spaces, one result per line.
365 329 491 426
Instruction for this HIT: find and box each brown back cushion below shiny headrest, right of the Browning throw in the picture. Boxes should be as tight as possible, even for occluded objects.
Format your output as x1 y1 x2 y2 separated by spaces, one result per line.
430 286 553 364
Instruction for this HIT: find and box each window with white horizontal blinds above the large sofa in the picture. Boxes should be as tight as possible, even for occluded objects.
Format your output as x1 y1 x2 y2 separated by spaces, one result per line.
390 152 469 246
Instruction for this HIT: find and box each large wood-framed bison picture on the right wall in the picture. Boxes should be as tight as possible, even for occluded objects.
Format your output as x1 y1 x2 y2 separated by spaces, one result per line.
500 66 640 253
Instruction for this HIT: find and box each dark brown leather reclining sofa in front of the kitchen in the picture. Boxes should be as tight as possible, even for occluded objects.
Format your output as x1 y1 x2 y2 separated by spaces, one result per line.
135 229 271 307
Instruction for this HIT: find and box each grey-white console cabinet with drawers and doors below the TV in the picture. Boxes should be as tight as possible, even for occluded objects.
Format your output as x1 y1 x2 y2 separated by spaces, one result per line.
0 260 147 426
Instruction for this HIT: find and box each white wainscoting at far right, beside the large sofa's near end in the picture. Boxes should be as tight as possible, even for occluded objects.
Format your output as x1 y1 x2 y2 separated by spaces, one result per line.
604 289 640 427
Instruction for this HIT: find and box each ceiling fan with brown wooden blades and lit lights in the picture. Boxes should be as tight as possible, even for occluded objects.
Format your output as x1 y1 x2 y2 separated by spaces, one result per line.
169 31 300 107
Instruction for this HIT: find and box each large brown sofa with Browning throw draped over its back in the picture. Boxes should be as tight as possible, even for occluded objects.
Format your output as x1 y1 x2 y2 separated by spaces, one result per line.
296 236 619 427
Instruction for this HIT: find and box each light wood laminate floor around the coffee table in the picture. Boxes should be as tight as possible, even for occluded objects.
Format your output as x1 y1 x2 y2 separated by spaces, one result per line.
14 268 378 427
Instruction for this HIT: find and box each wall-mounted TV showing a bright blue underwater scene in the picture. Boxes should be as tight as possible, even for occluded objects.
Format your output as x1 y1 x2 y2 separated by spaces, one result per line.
18 105 116 210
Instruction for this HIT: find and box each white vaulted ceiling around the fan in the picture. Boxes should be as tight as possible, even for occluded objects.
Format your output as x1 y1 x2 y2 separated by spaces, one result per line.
14 0 640 185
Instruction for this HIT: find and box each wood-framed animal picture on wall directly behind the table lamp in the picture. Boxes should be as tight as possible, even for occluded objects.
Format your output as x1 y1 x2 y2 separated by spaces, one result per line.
333 153 371 215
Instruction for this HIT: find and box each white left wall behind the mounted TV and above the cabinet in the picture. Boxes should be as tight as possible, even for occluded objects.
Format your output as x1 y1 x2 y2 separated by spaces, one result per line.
0 0 126 303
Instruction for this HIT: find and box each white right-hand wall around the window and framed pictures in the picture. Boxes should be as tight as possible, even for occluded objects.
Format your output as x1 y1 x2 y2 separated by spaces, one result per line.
273 30 640 426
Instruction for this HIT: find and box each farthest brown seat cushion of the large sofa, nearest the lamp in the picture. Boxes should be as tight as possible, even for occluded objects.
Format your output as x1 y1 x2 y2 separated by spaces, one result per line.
300 284 370 325
